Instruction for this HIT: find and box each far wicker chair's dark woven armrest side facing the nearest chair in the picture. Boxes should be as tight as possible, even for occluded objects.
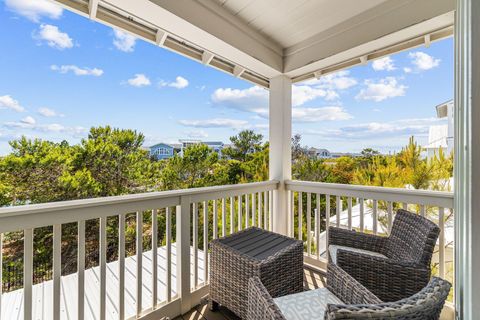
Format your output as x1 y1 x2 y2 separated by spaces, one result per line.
337 250 431 302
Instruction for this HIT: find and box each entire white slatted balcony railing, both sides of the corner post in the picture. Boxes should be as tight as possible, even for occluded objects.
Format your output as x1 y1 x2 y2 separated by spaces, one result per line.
0 181 453 319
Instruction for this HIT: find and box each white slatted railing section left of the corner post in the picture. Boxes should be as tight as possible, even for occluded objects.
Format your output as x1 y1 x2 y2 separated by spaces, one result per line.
0 181 278 320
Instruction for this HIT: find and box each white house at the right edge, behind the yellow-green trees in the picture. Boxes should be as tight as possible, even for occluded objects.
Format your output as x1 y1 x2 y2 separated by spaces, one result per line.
423 100 454 158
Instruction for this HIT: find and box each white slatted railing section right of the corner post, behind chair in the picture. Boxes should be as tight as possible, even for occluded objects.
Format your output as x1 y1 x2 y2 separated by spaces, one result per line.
285 181 454 278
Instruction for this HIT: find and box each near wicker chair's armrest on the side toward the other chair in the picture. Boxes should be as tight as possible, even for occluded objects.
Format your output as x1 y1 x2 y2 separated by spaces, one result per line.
327 263 382 304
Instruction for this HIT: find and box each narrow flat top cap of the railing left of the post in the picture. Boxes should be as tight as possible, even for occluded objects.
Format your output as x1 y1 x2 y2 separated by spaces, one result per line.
0 180 279 221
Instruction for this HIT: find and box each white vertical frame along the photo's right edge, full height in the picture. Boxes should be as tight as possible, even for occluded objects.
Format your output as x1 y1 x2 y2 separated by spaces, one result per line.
454 0 480 320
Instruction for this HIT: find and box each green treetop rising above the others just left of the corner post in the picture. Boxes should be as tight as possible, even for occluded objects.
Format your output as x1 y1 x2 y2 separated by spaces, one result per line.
222 130 263 161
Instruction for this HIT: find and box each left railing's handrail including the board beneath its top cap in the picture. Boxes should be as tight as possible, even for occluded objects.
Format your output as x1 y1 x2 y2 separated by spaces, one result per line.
0 180 279 233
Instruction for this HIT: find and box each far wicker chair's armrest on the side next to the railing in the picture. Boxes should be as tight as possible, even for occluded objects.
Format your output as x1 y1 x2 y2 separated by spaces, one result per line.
328 227 388 254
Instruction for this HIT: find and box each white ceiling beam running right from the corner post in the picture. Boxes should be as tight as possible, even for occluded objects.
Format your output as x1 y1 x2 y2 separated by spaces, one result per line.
284 0 455 78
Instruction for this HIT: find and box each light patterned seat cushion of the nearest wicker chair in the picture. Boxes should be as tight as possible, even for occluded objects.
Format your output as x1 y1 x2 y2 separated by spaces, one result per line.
273 288 343 320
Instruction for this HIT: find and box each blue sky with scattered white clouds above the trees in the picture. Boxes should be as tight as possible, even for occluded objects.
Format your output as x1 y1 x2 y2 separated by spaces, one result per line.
0 0 453 155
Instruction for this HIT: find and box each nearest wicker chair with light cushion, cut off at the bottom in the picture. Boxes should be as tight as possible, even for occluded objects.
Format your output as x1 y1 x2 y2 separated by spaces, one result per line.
247 265 451 320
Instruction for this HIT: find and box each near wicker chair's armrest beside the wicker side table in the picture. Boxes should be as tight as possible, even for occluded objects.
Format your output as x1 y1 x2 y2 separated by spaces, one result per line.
247 277 286 320
